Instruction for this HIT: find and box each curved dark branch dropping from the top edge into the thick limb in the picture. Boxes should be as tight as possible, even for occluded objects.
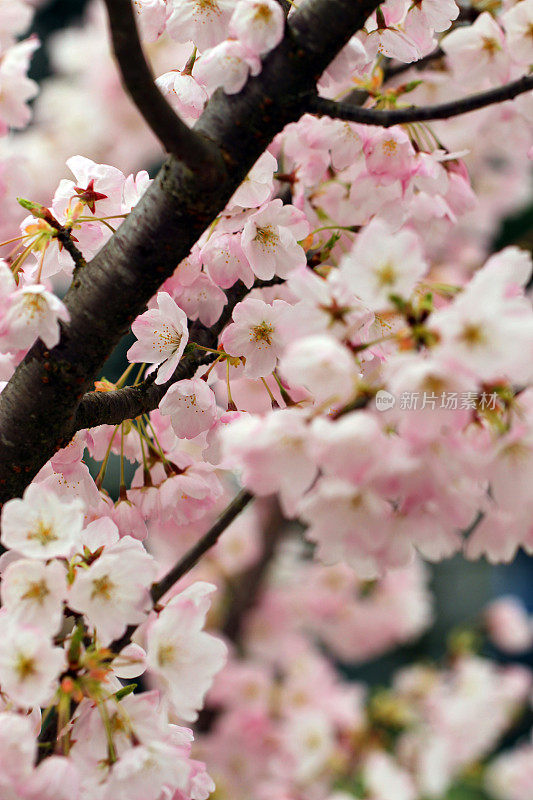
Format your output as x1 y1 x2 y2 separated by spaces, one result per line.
104 0 224 180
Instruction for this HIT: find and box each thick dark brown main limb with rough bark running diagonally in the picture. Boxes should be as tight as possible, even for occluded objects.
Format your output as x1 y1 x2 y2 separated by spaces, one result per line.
0 0 377 503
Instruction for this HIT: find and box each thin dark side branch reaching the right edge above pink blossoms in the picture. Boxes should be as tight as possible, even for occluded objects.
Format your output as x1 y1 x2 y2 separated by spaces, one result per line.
308 75 533 128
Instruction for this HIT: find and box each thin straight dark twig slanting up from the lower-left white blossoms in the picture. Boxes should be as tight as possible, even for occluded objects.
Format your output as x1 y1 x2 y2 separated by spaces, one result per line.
109 490 253 653
